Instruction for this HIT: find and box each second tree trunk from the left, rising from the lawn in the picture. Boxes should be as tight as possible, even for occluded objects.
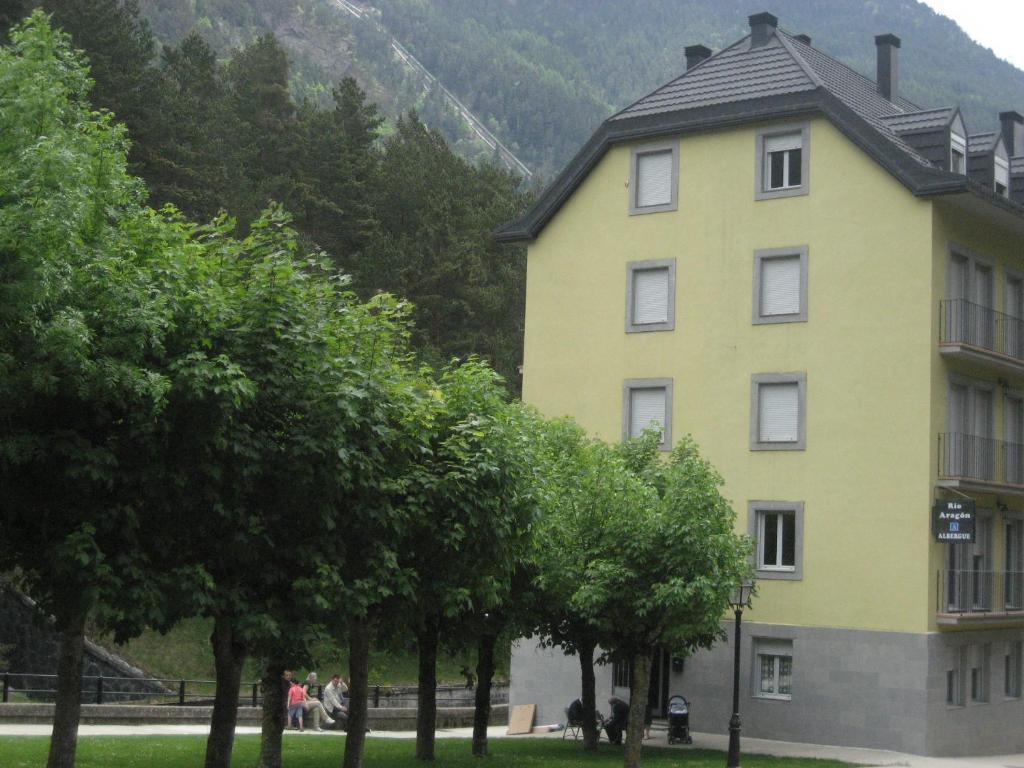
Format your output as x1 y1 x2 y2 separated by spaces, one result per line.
206 615 246 768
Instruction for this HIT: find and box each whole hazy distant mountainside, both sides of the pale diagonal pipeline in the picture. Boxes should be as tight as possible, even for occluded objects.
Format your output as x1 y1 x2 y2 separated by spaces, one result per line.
141 0 1024 178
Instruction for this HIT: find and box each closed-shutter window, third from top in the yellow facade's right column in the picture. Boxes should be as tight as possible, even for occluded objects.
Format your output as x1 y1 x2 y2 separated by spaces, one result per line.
751 373 807 451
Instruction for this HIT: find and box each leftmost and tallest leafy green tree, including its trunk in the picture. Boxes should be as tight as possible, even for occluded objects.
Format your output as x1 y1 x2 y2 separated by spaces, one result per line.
0 12 177 768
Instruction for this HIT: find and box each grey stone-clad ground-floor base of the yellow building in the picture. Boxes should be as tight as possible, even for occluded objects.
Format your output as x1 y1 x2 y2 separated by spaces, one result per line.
509 622 1024 757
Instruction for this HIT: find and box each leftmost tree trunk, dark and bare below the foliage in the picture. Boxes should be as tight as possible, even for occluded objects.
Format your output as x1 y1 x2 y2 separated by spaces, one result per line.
46 607 86 768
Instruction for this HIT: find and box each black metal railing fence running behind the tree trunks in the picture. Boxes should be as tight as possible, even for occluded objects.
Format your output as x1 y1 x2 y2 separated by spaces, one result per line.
0 672 508 709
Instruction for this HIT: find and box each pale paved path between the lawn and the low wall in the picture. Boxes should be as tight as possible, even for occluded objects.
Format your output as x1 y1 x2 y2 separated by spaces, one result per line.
0 724 1024 768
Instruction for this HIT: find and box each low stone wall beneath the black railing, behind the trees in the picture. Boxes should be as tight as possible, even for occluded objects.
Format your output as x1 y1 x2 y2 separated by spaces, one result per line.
0 703 509 731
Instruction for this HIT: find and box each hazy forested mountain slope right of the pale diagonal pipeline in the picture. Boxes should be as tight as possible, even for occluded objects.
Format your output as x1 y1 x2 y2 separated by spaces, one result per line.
373 0 1024 174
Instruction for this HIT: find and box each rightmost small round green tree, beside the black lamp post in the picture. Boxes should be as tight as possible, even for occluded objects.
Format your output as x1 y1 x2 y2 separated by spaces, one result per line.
589 430 751 768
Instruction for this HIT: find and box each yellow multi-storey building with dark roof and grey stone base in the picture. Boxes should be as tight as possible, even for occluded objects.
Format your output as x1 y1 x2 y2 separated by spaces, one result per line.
499 13 1024 755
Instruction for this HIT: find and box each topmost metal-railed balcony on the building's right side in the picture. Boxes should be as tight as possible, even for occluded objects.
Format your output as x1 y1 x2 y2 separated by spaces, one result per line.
939 299 1024 376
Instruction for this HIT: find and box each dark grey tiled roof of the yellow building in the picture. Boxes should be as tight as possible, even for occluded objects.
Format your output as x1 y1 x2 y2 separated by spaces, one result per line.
496 22 1024 241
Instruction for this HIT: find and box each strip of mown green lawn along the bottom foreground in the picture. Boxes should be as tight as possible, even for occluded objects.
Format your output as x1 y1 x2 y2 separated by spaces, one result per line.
0 733 864 768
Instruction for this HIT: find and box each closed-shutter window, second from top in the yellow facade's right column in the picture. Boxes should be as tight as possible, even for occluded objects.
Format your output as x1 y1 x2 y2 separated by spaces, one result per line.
754 246 807 325
